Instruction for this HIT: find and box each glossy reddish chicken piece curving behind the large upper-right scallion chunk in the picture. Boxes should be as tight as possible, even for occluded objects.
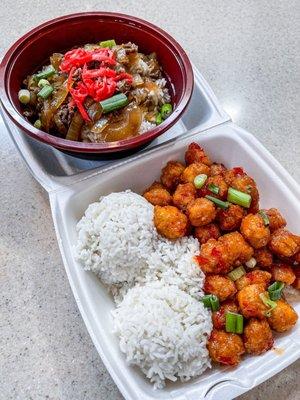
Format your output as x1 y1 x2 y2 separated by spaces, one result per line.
224 167 259 214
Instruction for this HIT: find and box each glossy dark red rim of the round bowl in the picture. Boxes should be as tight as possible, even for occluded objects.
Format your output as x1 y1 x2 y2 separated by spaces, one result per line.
0 11 194 154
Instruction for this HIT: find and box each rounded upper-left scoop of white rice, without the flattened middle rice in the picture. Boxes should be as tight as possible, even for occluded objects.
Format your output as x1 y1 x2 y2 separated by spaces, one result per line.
76 191 157 285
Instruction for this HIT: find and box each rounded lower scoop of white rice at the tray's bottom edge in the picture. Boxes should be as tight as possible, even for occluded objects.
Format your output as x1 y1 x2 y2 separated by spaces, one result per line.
113 281 211 388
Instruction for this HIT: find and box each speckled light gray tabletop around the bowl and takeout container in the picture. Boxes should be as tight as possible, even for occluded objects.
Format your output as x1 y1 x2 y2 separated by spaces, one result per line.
0 0 300 400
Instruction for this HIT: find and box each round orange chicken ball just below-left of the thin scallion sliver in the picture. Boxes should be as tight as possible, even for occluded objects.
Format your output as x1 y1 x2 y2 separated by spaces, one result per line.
187 198 217 226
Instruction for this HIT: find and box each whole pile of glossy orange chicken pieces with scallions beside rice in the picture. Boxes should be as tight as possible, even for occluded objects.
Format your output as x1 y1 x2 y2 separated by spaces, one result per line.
144 143 300 366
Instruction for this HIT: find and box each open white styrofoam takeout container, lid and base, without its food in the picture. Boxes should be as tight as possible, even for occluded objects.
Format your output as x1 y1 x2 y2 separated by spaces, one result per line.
1 64 300 400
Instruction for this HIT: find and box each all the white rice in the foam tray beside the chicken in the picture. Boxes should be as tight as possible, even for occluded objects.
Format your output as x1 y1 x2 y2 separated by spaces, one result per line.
76 191 211 388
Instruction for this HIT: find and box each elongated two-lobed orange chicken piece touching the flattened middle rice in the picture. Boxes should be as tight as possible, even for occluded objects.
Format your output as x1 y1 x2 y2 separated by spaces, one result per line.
196 232 253 274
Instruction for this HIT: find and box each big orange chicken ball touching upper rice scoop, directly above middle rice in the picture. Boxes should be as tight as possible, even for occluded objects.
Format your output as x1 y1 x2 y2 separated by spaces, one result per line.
154 206 189 239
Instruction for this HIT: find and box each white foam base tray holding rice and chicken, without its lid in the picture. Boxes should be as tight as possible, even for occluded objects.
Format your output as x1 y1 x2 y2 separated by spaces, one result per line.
50 123 300 400
